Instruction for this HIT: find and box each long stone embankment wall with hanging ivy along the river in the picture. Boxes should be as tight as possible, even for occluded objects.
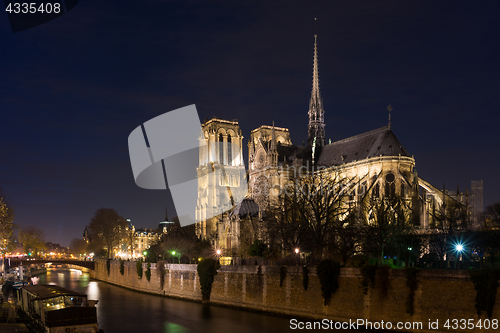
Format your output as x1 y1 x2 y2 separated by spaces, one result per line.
91 260 500 332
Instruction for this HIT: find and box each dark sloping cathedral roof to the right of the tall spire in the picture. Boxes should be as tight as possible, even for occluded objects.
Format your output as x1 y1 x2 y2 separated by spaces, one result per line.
317 126 411 167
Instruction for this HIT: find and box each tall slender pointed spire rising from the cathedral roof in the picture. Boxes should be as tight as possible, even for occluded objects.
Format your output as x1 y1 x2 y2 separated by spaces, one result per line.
307 29 325 147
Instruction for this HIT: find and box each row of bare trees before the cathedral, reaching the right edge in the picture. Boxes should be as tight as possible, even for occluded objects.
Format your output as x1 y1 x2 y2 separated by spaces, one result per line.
246 169 500 264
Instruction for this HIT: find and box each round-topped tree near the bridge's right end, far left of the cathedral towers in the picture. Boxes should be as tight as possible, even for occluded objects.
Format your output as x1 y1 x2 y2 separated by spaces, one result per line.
89 208 127 258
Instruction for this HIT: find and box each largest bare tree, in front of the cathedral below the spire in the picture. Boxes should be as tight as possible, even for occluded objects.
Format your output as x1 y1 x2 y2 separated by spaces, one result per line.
268 170 356 260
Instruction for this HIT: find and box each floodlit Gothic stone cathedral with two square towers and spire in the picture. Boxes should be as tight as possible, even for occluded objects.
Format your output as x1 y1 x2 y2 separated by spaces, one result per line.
196 35 482 255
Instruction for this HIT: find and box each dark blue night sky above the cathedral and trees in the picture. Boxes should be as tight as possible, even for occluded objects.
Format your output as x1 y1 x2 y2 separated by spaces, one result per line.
0 0 500 246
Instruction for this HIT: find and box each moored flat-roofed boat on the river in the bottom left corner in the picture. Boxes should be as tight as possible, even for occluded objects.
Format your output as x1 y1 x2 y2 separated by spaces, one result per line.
18 285 102 333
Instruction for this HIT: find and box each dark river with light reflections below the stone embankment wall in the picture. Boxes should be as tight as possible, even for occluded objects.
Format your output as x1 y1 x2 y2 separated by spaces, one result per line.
37 268 361 333
